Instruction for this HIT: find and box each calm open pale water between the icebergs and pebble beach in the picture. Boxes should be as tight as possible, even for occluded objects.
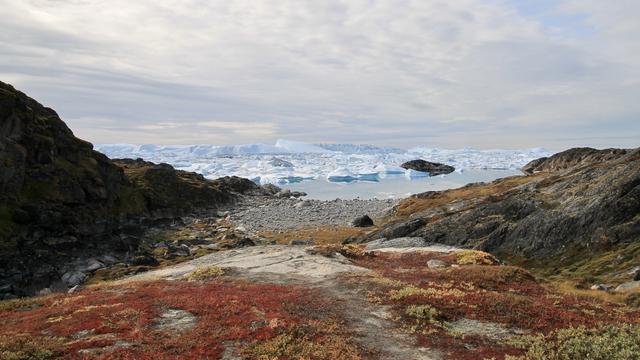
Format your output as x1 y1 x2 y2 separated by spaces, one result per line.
281 169 523 200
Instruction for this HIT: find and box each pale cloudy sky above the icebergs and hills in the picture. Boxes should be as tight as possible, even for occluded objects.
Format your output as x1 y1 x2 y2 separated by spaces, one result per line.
0 0 640 150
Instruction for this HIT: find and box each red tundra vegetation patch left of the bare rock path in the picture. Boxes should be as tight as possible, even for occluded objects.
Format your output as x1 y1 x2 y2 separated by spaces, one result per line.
0 278 360 359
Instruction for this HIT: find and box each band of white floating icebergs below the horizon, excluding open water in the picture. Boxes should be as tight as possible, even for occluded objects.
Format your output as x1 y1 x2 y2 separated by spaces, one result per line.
95 139 550 184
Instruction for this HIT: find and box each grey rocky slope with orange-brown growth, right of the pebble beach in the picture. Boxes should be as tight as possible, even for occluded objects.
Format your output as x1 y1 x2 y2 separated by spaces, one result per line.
356 149 640 259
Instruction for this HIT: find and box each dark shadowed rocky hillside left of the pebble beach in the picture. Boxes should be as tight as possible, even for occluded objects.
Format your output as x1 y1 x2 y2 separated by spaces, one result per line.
0 82 256 298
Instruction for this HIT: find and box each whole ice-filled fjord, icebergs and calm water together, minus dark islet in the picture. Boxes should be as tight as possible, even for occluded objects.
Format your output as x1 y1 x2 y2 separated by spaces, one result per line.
95 140 550 199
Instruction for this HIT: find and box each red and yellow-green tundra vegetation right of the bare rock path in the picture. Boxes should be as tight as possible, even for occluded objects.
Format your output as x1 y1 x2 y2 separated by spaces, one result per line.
347 251 640 360
